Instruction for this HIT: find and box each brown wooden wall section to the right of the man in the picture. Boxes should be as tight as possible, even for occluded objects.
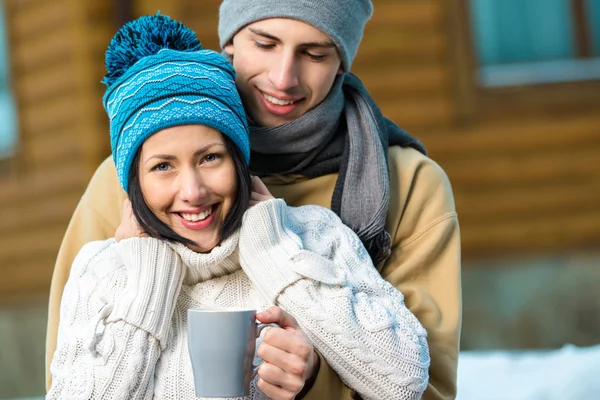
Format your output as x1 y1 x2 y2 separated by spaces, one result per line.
354 0 600 261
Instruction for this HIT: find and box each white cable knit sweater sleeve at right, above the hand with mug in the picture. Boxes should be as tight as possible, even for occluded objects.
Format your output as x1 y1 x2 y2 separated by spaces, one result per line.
240 199 430 399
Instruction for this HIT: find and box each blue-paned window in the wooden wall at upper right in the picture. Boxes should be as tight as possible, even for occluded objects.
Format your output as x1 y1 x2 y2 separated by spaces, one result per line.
470 0 600 87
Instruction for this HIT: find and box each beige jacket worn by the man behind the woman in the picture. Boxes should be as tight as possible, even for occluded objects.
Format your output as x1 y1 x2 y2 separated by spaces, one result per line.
46 147 462 400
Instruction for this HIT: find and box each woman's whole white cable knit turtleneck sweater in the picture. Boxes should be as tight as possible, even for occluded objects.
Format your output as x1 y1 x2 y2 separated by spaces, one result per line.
47 200 429 400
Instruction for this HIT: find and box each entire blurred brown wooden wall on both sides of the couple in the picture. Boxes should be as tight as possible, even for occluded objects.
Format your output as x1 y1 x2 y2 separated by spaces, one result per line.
0 0 600 302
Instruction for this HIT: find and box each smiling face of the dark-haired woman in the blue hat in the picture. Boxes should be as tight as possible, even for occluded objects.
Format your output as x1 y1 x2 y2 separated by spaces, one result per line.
139 125 238 252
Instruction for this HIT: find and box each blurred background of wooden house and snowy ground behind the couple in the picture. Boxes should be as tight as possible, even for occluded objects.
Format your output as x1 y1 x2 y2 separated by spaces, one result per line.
0 0 600 400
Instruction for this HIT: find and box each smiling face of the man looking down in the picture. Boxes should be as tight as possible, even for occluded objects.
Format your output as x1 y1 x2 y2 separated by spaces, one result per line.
225 18 342 127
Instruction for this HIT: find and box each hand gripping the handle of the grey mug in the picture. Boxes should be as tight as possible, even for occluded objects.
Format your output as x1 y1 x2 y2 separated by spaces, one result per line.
256 306 319 400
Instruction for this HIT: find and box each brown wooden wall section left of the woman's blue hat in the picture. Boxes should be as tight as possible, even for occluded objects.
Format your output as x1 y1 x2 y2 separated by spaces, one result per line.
0 0 113 302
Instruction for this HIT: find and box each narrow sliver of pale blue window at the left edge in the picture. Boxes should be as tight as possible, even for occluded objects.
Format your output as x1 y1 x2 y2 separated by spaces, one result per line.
0 0 17 158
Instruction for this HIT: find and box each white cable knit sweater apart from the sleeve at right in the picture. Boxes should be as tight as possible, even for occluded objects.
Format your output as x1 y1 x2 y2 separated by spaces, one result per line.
47 233 272 400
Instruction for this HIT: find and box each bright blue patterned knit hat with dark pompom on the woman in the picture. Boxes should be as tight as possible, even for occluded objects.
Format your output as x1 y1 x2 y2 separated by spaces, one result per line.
103 14 250 190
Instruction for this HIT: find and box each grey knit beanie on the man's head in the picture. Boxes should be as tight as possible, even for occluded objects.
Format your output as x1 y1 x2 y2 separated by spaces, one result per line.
219 0 373 71
